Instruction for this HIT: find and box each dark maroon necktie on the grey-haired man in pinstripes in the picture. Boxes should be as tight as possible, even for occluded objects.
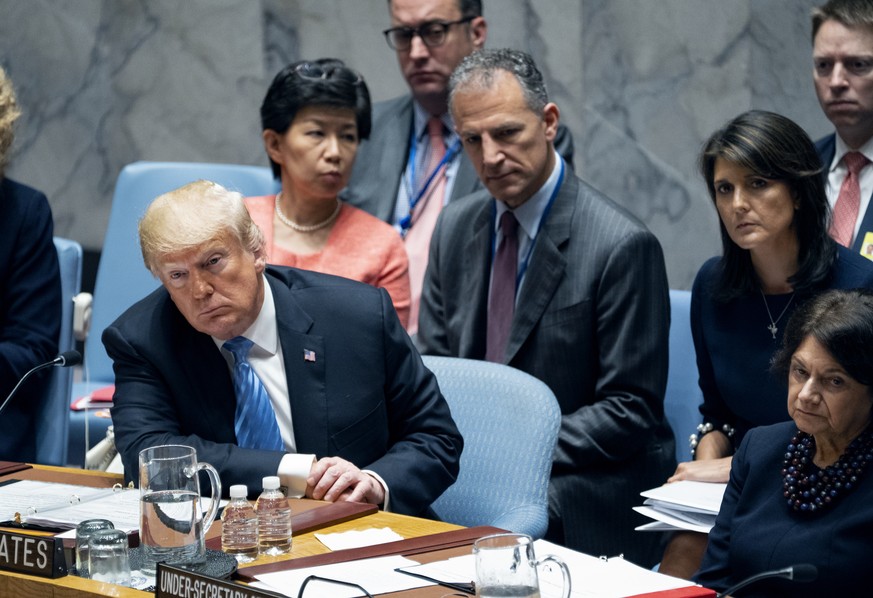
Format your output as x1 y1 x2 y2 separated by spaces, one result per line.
485 210 518 363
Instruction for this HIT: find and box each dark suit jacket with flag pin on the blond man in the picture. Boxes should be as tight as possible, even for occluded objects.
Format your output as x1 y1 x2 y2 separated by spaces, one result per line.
103 266 463 514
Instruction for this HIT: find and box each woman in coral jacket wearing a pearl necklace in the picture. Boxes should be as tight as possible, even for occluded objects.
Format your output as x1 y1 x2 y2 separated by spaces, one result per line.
246 58 410 326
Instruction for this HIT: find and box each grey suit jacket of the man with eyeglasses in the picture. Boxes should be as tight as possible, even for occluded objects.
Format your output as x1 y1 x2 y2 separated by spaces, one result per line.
341 95 573 224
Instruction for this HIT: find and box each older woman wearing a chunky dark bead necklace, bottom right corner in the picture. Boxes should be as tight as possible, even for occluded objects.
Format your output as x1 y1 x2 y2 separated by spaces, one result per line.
695 290 873 596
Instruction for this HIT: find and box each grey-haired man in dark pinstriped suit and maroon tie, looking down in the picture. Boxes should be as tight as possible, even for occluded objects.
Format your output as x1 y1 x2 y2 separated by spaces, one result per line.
419 50 675 565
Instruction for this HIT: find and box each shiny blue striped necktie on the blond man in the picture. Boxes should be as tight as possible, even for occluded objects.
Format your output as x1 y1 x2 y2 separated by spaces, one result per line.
222 336 285 451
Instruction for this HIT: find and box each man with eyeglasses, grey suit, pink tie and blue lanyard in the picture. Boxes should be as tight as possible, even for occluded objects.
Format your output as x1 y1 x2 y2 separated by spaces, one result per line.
342 0 573 335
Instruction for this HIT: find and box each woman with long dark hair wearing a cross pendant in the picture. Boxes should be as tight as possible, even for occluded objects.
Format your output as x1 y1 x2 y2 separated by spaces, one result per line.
662 111 873 577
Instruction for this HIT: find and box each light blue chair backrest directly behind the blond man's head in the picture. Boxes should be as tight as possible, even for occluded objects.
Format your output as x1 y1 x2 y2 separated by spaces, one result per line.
85 162 279 389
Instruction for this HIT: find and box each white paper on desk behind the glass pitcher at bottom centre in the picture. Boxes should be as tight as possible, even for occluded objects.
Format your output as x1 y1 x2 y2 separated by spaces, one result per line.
392 540 694 598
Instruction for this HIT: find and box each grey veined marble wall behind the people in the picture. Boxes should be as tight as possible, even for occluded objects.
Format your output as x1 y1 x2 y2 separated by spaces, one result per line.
0 0 829 288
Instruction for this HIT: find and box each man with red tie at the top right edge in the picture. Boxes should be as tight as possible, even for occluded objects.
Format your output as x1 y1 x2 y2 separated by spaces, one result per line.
812 0 873 259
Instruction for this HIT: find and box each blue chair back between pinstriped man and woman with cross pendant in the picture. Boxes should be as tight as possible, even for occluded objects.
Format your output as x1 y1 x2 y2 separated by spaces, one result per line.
664 289 703 463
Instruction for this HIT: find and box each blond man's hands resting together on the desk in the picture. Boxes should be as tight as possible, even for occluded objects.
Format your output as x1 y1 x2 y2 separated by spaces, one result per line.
306 457 385 505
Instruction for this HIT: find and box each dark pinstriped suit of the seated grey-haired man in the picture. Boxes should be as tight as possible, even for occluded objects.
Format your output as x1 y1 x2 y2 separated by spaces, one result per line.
418 173 675 561
